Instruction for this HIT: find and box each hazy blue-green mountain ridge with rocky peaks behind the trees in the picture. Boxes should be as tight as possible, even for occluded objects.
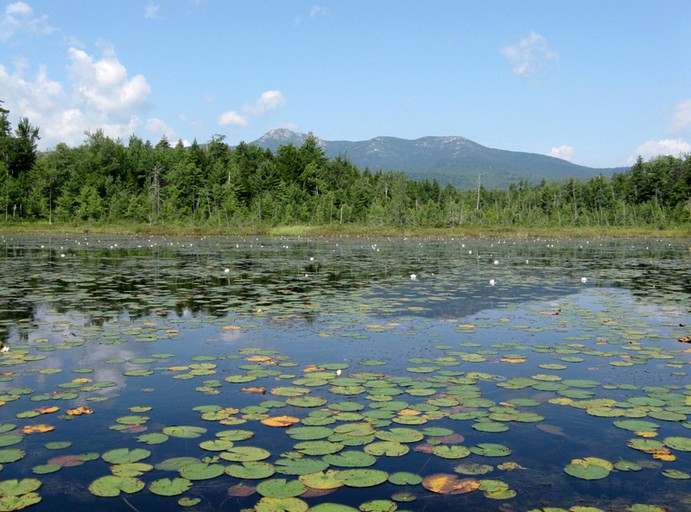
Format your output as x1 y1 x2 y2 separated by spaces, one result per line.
253 128 627 188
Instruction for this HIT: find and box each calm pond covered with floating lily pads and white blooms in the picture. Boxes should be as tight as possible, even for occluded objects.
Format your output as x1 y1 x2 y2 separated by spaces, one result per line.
0 234 691 512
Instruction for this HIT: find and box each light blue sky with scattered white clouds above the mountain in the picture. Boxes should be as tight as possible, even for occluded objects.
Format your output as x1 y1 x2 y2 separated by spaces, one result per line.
0 0 691 167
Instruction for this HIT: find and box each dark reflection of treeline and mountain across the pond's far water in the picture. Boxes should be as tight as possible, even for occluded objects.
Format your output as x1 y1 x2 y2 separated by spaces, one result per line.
0 236 691 338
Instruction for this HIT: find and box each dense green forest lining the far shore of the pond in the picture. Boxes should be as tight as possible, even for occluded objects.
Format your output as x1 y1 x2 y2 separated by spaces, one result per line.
0 102 691 229
